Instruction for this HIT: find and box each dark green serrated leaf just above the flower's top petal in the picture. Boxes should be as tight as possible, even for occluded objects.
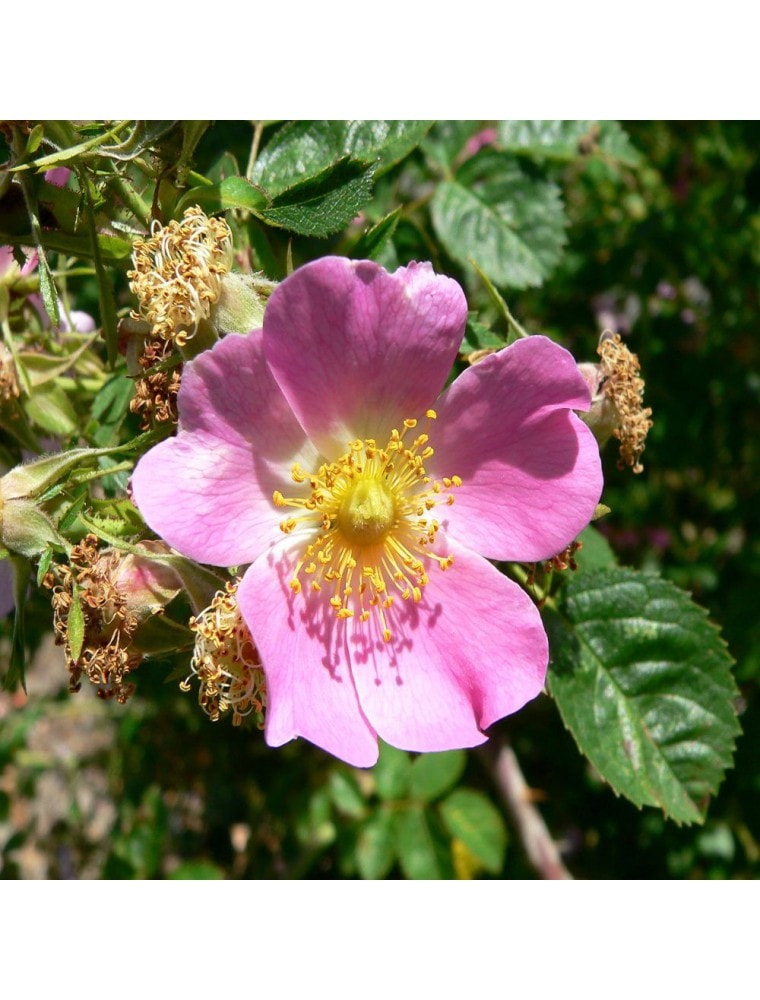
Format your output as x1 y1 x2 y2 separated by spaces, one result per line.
257 157 375 236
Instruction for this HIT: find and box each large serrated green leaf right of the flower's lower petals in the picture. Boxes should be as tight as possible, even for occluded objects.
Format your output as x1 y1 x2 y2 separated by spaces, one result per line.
547 569 739 823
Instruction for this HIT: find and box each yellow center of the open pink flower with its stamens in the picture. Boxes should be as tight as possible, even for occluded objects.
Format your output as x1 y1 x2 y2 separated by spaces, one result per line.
273 410 462 642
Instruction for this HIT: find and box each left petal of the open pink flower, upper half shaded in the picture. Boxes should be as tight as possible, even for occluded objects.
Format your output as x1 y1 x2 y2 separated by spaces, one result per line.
132 331 316 566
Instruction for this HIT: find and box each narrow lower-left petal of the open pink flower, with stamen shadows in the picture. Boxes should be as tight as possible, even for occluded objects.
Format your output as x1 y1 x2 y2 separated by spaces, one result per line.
238 540 377 767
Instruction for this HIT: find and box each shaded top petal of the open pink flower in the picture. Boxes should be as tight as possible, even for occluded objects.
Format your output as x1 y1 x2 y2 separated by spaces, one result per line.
264 257 467 459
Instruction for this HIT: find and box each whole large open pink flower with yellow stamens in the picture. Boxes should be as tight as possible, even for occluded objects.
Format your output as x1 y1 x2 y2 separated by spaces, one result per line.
132 257 602 766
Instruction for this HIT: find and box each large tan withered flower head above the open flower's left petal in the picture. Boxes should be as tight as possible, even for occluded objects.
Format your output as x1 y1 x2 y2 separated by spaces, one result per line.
128 205 232 347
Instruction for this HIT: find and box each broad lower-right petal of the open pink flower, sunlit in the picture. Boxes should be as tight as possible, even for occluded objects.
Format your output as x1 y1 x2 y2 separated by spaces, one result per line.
348 544 548 751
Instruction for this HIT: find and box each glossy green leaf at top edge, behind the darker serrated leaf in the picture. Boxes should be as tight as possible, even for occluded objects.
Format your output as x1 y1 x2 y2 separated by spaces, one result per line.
253 121 432 195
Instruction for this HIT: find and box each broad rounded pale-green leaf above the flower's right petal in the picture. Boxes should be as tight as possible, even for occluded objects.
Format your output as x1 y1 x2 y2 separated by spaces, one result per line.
431 151 567 288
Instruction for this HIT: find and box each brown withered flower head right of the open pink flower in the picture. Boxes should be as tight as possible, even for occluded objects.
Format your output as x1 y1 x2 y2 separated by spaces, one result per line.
579 330 652 473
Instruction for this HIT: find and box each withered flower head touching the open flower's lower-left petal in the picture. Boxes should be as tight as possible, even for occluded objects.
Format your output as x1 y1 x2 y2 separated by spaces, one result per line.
180 583 266 727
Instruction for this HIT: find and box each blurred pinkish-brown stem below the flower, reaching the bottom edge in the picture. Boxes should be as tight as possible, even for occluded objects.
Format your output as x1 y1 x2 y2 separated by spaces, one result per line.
484 743 573 879
